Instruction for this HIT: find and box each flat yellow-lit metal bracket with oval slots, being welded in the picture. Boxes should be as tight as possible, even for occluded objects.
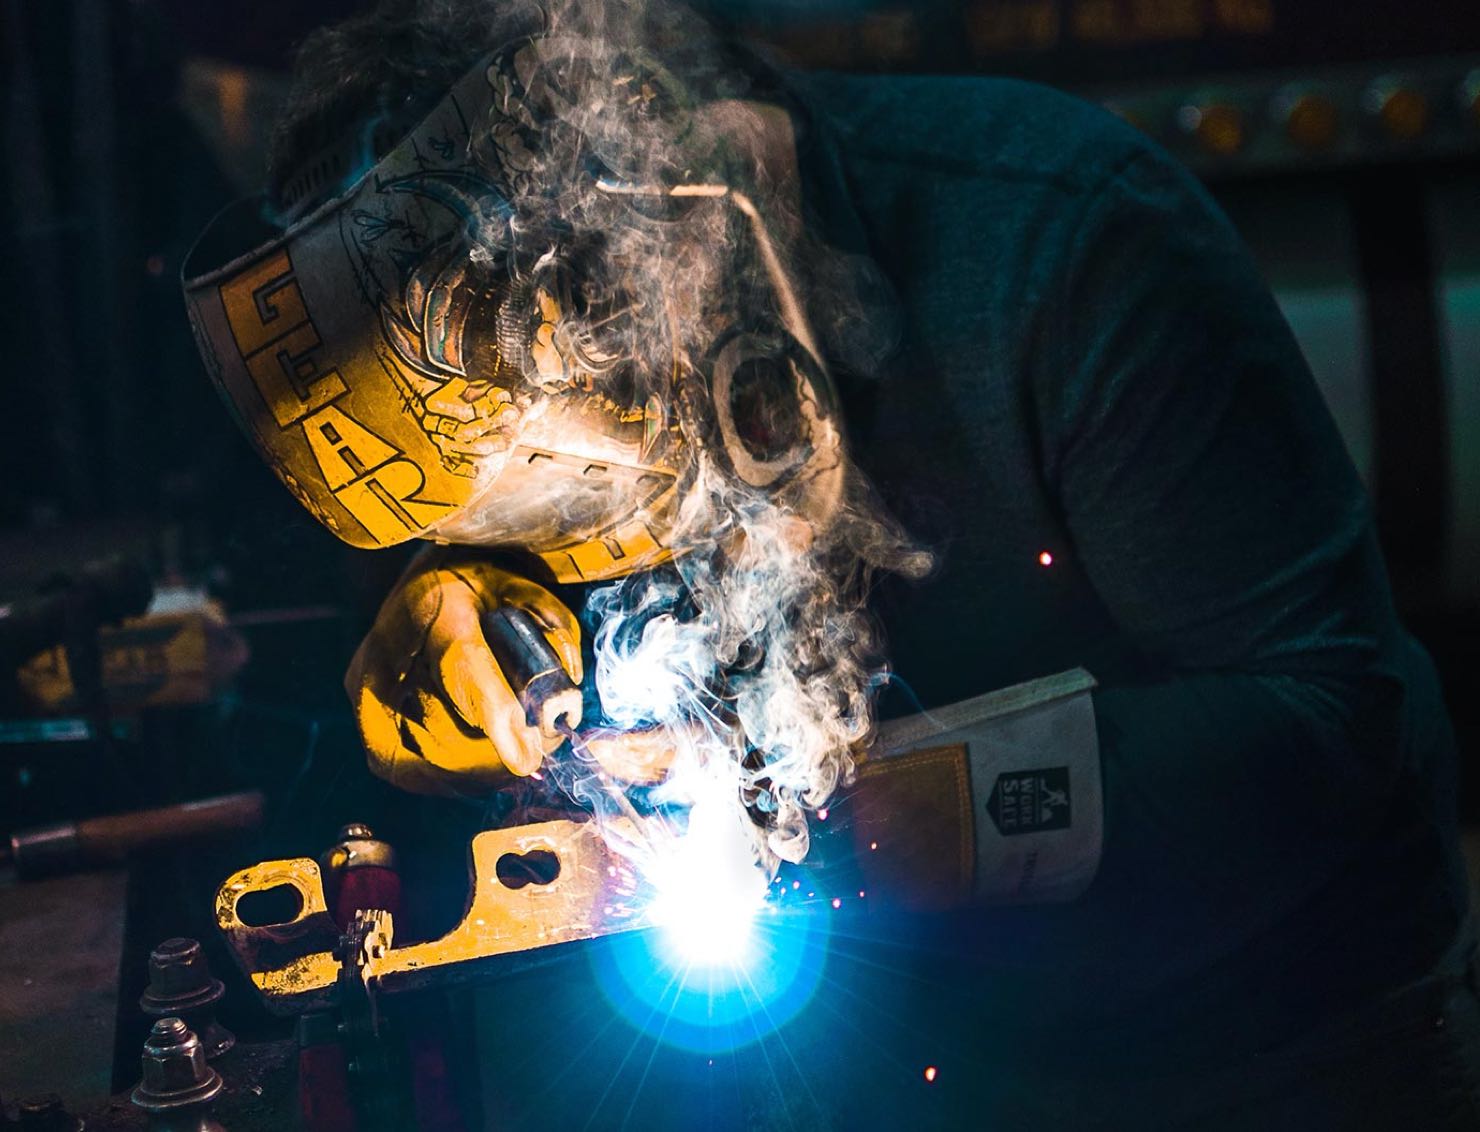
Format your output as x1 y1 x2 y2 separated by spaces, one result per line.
216 821 648 1015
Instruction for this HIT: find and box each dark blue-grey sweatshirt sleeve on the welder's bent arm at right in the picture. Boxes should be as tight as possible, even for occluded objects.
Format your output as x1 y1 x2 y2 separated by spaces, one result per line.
1035 139 1405 960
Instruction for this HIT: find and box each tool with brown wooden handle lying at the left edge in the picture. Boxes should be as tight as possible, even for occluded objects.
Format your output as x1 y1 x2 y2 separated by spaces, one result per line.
0 790 263 877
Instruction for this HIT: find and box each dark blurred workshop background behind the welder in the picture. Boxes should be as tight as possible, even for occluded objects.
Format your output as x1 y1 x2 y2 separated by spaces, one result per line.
0 0 1480 1112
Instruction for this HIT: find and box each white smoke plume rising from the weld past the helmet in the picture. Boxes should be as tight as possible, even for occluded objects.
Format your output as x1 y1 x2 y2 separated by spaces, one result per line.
449 1 929 870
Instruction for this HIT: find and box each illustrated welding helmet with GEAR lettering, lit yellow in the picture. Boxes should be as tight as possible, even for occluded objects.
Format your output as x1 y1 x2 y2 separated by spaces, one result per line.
184 37 841 582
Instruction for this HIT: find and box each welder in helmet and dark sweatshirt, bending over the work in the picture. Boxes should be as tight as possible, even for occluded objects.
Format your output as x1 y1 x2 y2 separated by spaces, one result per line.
189 0 1480 1129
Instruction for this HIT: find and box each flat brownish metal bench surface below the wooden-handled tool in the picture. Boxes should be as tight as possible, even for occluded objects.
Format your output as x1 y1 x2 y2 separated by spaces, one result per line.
0 872 127 1111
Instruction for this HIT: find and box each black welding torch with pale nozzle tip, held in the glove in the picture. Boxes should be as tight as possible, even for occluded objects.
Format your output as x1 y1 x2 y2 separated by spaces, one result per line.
482 605 642 826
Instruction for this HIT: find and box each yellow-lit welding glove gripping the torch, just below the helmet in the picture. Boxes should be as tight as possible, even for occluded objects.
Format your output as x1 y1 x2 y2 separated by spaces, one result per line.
345 548 582 795
